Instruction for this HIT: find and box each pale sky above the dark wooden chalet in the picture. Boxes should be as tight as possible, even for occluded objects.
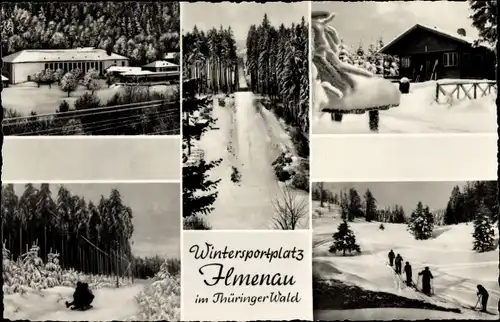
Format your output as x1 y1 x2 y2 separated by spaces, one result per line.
312 1 478 47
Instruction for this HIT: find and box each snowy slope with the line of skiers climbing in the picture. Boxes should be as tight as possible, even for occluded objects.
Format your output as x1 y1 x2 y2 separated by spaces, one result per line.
313 203 500 320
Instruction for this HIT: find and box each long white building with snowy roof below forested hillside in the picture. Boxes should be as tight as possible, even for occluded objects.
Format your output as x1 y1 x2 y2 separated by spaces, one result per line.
2 48 129 84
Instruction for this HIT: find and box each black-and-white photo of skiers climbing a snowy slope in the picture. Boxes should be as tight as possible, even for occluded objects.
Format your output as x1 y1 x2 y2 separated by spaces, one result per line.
312 181 500 321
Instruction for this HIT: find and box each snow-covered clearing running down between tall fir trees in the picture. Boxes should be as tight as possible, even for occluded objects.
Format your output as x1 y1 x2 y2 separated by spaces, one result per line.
200 76 309 229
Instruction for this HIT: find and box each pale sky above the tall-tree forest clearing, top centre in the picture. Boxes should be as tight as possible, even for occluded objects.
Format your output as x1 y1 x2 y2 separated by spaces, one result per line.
181 2 309 42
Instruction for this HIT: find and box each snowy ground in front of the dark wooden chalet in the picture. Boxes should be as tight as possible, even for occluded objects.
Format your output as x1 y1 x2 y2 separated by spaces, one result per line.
312 80 497 134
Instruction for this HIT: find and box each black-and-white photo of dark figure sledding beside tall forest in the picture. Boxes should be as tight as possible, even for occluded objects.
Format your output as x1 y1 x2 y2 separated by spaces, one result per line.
1 183 181 321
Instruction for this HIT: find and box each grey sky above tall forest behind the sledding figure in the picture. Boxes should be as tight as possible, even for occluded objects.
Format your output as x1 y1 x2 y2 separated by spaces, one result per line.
14 183 181 258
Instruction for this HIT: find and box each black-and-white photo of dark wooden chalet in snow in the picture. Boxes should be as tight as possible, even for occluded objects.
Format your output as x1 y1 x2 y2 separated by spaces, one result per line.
311 0 498 134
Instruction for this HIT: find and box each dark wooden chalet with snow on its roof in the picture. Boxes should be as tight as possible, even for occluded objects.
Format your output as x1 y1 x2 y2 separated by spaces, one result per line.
379 24 495 82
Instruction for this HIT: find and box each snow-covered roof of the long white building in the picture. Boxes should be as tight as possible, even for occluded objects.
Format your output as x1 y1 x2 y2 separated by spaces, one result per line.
3 47 128 63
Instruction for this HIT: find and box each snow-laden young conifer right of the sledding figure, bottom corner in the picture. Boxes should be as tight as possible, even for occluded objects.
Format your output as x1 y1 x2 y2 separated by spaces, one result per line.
136 262 181 321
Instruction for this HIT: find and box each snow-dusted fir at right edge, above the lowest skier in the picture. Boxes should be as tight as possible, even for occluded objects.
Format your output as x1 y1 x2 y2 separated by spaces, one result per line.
472 202 496 253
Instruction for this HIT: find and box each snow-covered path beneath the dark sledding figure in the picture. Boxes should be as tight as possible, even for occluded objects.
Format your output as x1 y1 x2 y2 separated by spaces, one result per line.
4 281 149 321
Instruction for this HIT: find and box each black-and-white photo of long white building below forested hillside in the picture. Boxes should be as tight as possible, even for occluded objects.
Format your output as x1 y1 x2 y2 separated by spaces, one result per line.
0 1 181 136
